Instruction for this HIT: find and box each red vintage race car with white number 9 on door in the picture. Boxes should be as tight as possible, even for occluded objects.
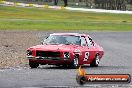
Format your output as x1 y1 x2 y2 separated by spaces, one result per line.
27 33 104 68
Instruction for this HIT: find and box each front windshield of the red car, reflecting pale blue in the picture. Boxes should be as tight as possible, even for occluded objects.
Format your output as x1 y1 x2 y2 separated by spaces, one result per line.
43 35 81 45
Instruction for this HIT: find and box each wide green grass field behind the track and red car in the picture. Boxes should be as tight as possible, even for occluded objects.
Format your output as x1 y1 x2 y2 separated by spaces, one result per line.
0 6 132 31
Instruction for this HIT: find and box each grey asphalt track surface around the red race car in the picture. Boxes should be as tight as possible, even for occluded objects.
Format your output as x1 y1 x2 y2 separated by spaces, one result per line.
0 31 132 88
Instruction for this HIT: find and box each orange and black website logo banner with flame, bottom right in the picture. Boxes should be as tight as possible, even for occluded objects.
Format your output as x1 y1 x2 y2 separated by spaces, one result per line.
76 67 131 85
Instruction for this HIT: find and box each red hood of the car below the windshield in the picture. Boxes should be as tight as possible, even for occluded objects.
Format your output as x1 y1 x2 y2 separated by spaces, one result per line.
29 44 79 51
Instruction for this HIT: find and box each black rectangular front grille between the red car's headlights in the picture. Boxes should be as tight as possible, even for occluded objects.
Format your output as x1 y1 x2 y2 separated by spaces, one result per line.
36 51 60 57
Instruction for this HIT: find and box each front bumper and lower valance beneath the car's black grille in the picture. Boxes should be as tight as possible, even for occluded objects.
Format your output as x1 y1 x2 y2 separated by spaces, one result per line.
27 56 71 65
